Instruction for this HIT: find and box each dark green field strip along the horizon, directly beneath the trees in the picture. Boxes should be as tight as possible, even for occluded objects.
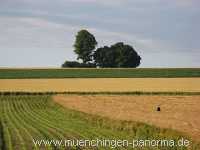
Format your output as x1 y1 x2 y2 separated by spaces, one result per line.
0 68 200 79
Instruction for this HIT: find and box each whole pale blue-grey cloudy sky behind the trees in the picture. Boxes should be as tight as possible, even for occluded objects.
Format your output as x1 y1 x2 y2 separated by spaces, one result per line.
0 0 200 68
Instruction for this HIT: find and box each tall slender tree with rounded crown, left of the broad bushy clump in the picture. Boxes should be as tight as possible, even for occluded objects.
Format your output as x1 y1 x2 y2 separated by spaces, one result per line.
74 30 97 63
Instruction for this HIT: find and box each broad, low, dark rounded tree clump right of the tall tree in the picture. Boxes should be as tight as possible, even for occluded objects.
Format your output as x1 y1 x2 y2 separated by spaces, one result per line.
93 42 141 68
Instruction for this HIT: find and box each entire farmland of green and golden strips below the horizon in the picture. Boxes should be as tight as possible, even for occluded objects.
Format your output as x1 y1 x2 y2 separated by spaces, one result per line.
0 68 200 150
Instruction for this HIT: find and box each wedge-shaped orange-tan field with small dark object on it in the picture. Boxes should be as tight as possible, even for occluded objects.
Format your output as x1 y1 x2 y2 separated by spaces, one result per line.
54 95 200 141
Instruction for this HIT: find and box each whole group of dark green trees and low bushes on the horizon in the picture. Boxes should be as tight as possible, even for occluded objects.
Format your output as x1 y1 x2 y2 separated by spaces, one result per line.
62 30 141 68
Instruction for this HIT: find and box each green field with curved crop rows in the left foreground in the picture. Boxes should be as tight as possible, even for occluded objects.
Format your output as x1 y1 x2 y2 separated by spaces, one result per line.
0 95 200 150
